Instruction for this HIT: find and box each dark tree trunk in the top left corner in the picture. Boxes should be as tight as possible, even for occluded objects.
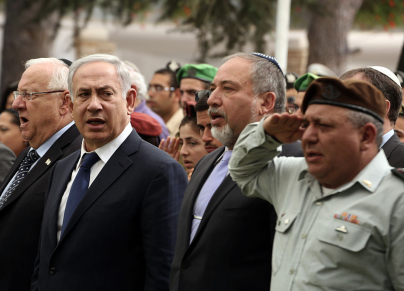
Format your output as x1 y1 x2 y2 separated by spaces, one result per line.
0 0 57 102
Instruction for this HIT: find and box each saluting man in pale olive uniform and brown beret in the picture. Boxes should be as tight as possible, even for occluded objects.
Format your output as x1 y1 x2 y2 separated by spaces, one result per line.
229 78 404 291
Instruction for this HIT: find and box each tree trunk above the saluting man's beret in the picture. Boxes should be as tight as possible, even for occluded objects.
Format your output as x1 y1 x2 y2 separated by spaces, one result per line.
308 0 363 75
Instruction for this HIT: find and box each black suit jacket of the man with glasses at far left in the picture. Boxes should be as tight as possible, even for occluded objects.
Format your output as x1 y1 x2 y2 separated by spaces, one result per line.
0 125 82 291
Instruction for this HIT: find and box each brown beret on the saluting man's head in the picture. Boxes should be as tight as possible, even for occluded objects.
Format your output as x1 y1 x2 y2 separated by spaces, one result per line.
301 77 386 123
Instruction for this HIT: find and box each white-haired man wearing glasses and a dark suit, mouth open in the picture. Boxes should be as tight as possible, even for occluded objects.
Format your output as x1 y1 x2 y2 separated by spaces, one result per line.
0 58 81 290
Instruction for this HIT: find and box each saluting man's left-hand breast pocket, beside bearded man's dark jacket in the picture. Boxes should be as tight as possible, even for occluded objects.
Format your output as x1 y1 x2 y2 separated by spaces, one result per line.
272 211 298 274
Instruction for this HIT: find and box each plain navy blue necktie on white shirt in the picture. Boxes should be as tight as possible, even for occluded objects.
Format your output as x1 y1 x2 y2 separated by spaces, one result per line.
62 152 100 233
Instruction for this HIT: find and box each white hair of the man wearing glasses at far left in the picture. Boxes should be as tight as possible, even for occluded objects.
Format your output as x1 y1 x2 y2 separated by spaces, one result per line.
25 58 69 91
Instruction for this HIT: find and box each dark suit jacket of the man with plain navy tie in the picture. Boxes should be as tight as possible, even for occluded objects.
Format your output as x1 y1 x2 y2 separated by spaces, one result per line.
32 131 188 291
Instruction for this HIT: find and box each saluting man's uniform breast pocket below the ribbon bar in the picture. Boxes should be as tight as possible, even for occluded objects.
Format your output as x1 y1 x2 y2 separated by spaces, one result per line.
309 219 371 290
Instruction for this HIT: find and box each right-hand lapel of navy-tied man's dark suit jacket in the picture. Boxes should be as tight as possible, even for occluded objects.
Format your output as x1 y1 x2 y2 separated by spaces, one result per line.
59 131 141 244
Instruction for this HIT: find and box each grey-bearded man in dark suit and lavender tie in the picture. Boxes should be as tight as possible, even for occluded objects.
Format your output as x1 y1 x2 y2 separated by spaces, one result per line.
170 53 286 291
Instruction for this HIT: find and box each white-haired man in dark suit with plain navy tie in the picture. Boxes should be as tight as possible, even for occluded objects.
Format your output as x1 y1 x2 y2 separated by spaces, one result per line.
31 55 187 291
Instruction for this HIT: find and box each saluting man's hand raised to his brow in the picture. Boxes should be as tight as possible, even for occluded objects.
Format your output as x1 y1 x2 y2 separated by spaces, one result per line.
264 113 304 143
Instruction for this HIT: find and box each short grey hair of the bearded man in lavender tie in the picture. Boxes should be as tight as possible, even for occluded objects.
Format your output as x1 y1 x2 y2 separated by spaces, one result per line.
223 53 286 113
